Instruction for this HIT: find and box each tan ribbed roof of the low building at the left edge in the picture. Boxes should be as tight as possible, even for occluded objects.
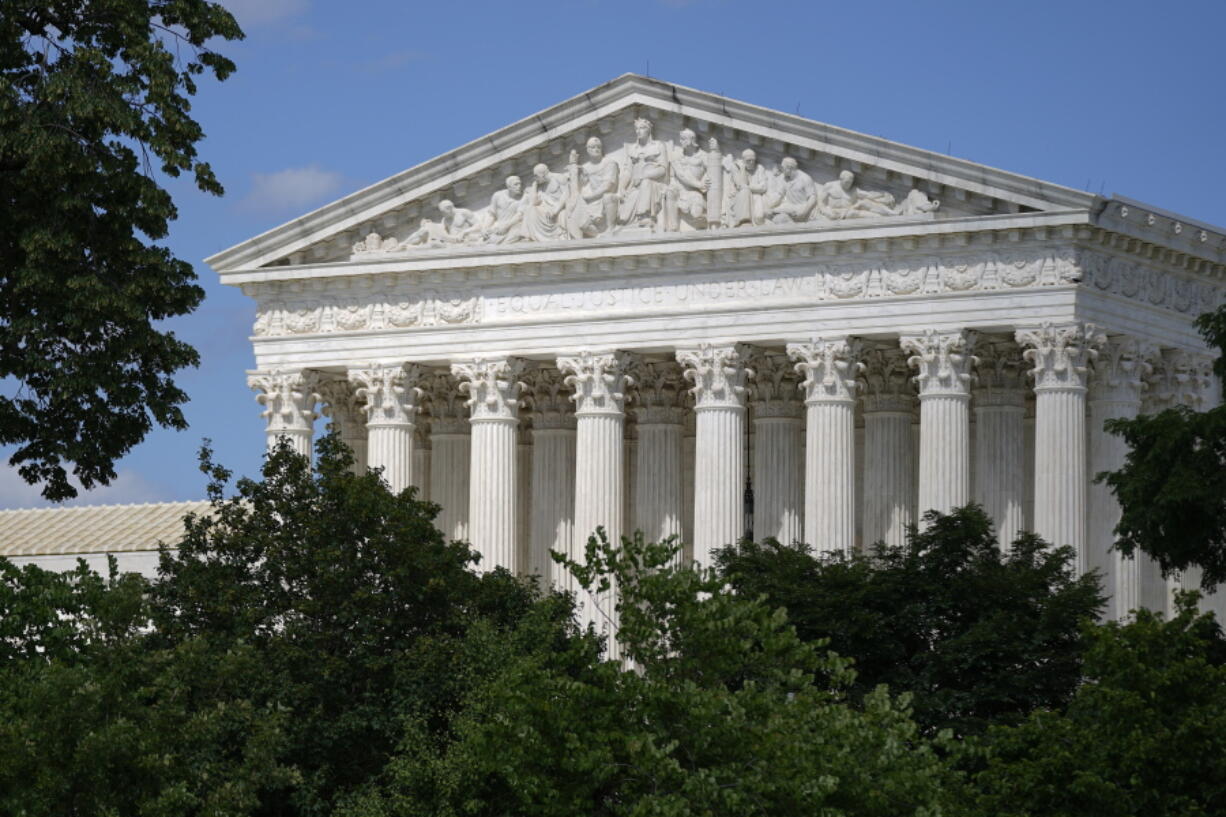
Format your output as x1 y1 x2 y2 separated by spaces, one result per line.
0 501 210 556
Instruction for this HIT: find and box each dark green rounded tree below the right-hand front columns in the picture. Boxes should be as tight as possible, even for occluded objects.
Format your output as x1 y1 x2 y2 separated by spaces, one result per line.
716 505 1103 735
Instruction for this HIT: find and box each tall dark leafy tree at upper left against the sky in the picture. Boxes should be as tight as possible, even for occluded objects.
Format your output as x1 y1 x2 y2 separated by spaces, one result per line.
0 0 243 499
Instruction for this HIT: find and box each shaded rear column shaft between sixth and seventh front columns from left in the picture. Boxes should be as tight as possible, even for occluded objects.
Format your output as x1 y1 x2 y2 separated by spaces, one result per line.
863 395 916 547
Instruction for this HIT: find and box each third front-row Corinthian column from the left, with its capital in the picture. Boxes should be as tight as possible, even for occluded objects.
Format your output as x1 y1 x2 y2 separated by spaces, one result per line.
451 358 525 573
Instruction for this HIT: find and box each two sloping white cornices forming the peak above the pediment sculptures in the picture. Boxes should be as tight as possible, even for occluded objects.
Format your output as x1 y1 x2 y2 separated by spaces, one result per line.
205 74 1098 272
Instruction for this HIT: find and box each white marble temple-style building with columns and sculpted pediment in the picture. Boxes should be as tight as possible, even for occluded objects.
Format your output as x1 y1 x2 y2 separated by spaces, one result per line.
208 76 1226 627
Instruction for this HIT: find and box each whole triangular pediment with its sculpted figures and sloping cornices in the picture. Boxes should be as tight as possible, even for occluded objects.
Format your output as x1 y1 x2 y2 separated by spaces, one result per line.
207 75 1095 272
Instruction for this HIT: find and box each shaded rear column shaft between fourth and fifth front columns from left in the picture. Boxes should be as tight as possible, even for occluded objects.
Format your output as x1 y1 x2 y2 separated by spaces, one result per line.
634 409 682 542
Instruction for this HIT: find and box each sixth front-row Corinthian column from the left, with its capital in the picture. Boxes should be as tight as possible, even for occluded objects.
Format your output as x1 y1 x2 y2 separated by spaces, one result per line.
787 337 864 553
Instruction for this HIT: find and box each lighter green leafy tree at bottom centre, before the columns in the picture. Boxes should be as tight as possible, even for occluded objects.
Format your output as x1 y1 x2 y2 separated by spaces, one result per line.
340 532 951 817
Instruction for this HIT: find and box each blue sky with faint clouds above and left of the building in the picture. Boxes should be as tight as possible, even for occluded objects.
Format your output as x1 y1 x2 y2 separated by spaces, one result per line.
0 0 1226 508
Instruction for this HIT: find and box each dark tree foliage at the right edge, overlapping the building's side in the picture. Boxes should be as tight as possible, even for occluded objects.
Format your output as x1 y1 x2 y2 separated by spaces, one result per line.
1098 305 1226 590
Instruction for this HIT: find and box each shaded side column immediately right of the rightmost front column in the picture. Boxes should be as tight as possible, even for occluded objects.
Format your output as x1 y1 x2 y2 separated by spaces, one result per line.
1086 336 1162 621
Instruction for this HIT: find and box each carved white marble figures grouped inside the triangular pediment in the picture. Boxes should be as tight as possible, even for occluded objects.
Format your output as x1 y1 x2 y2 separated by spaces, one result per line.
353 119 940 254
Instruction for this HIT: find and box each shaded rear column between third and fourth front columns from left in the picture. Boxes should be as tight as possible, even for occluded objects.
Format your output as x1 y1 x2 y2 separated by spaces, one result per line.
527 367 577 581
